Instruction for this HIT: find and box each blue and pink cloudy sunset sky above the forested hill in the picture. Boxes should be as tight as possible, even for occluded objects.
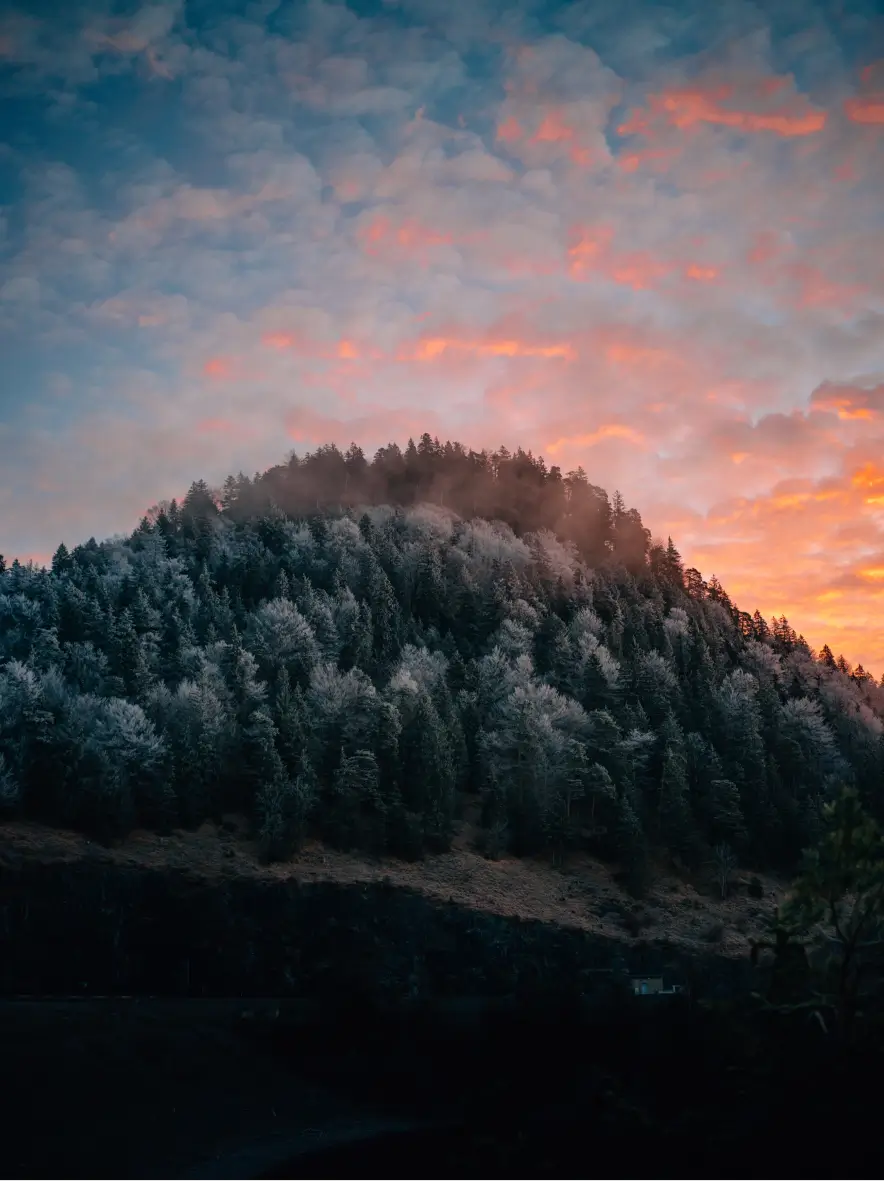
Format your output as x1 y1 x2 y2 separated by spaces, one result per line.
0 0 884 676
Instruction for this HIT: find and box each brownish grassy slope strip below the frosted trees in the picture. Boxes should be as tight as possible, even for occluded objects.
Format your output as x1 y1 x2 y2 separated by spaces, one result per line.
0 803 786 957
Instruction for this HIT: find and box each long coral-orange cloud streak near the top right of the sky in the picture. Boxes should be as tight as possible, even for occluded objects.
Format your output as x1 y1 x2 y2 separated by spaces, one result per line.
617 83 826 137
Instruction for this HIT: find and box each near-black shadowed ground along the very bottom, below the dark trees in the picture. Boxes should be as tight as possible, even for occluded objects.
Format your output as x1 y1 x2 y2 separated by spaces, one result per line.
6 1000 882 1181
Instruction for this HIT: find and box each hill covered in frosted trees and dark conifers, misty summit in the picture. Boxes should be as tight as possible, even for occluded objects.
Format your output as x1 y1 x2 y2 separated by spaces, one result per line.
0 436 884 885
